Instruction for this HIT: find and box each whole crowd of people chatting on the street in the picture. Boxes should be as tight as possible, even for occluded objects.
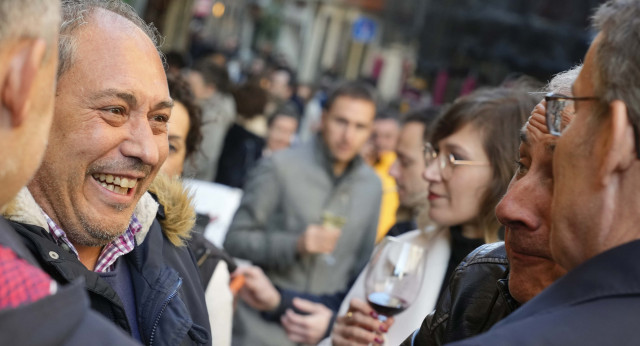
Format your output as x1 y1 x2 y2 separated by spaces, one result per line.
0 0 640 346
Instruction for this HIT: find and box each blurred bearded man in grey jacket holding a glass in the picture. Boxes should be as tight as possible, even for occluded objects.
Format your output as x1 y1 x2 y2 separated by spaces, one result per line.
224 82 382 346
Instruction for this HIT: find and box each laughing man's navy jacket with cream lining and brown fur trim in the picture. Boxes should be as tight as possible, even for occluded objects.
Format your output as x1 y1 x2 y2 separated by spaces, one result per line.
7 177 211 345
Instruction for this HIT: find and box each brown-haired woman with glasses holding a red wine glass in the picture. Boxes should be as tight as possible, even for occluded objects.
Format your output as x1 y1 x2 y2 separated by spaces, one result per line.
331 88 536 346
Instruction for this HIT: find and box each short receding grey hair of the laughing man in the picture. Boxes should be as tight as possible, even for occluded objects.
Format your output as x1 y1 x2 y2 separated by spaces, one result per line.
57 0 165 78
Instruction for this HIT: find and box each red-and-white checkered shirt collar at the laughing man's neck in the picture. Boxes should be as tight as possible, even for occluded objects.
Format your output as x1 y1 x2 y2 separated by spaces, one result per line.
42 211 142 273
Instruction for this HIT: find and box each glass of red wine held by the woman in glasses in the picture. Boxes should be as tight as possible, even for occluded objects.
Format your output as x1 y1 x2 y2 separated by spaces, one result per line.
365 236 425 328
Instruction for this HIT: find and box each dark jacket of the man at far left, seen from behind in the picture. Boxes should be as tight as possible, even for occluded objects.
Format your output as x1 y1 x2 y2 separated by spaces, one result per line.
0 217 138 346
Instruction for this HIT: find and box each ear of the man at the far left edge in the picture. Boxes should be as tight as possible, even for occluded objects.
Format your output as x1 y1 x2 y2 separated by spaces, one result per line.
0 39 47 127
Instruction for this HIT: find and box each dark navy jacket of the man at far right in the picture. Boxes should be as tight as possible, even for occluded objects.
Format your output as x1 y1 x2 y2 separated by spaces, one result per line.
448 240 640 346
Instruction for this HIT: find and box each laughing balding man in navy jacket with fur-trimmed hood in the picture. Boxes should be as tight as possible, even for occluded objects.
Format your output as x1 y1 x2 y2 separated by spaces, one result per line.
6 0 210 345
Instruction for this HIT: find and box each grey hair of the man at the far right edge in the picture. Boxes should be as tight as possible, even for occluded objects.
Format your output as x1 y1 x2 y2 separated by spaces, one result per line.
592 0 640 126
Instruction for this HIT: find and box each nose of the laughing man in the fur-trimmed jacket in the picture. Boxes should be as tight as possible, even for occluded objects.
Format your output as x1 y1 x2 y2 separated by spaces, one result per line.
120 117 160 166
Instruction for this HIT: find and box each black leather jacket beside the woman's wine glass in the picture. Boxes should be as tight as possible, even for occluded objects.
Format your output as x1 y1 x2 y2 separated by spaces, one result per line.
402 242 518 346
